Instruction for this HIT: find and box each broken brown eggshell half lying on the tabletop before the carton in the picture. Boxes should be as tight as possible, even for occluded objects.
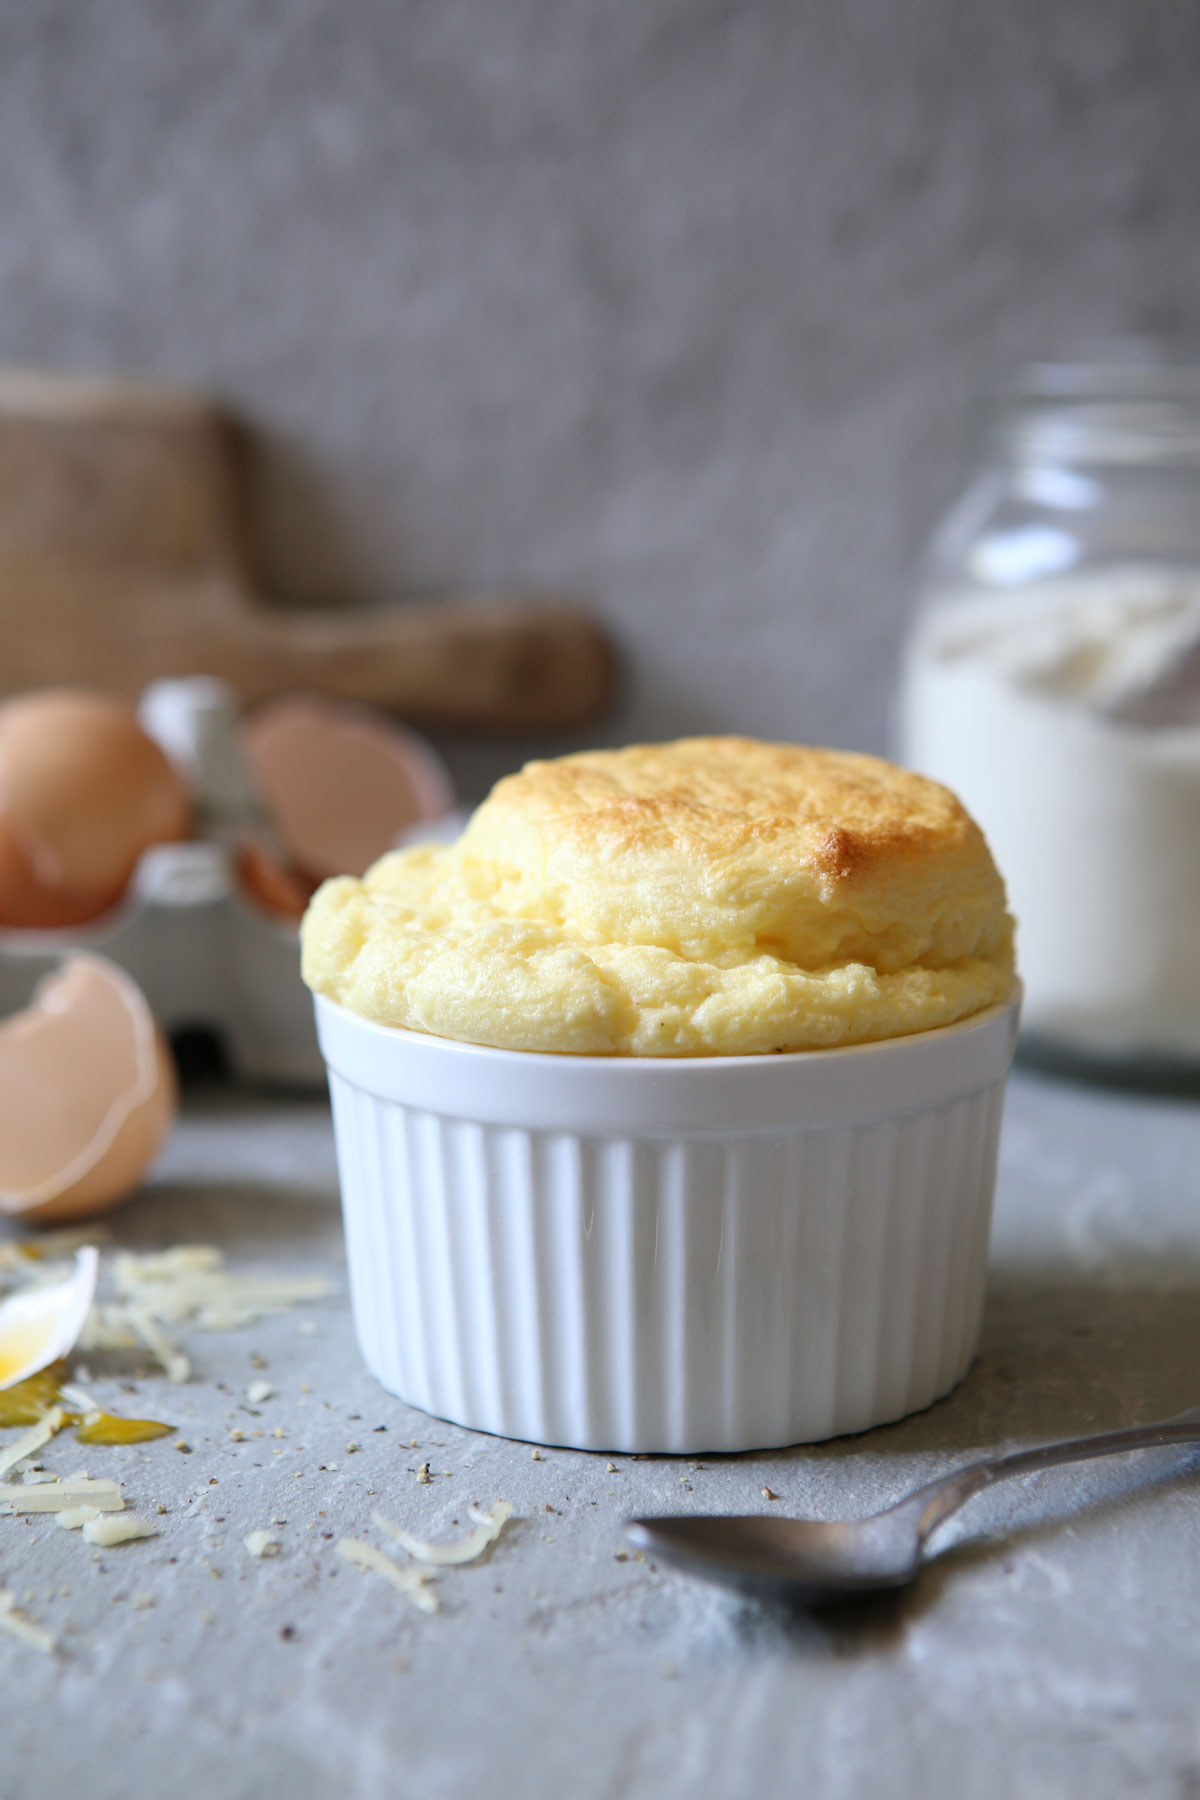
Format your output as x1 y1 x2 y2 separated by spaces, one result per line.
0 956 176 1224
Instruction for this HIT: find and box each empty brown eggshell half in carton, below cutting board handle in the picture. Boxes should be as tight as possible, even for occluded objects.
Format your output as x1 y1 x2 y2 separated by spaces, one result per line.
243 695 453 882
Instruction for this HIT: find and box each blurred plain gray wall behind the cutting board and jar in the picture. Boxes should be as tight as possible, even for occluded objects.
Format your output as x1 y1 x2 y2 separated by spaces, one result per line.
0 0 1200 787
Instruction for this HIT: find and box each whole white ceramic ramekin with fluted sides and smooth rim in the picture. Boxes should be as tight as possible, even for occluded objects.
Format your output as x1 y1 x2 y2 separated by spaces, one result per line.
317 994 1018 1453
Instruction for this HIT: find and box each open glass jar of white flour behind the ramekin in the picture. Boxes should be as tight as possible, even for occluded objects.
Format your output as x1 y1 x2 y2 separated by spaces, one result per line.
898 364 1200 1073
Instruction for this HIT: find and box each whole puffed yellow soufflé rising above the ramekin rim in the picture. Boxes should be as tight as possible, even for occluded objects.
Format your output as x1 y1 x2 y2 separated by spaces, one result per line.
302 738 1013 1057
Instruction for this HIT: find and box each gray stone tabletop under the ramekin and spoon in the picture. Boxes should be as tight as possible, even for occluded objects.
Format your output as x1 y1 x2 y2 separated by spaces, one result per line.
0 1073 1200 1800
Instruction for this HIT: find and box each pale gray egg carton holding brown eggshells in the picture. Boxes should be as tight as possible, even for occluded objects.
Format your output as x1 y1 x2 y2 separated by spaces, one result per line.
0 679 459 1087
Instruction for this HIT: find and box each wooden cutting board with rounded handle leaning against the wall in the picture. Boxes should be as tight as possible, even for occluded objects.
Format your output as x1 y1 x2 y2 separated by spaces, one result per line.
0 371 613 731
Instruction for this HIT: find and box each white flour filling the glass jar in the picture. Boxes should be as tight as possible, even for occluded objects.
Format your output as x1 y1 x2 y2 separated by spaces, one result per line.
900 565 1200 1060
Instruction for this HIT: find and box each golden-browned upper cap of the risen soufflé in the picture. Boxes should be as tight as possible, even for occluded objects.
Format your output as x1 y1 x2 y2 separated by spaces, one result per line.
462 738 1004 968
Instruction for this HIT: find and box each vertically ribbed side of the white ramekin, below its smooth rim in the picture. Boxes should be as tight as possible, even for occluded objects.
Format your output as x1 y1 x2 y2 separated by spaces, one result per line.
331 1075 1004 1453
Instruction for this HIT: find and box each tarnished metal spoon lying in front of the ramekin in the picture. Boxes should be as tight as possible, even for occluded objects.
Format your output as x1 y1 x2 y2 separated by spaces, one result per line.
626 1406 1200 1606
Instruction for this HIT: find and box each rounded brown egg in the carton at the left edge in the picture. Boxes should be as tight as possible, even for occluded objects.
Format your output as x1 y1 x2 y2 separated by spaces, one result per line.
0 689 191 929
